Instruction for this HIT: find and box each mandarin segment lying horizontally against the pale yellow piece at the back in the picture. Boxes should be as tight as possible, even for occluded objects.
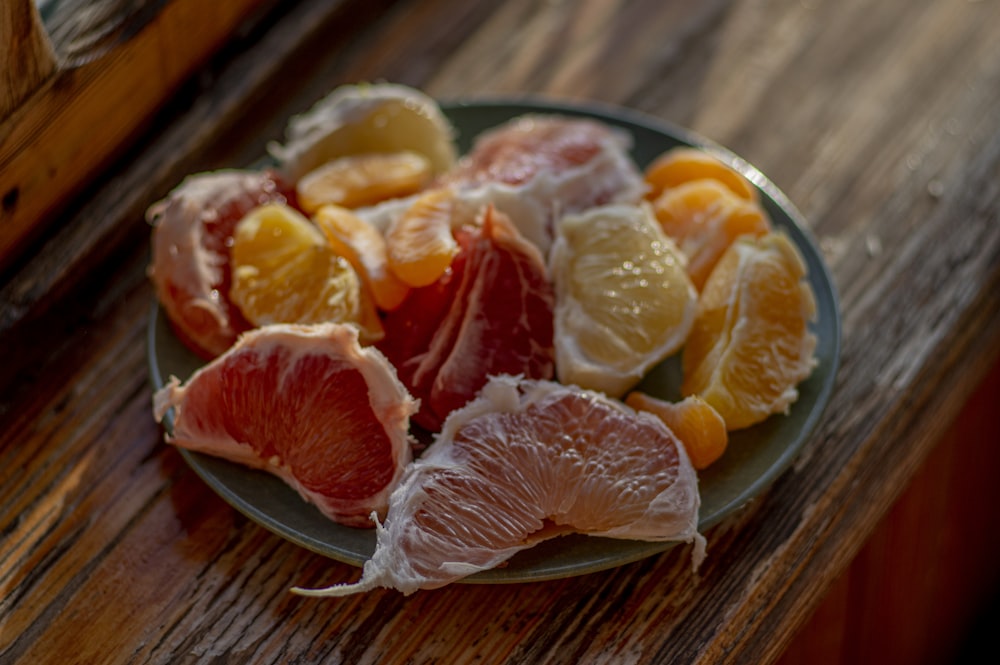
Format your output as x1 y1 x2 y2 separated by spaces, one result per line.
295 151 431 214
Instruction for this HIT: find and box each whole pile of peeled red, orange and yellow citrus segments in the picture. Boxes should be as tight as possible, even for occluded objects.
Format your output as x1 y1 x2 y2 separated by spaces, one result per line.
149 84 816 595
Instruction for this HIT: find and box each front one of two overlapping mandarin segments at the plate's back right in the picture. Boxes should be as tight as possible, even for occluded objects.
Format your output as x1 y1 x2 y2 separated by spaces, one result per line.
653 178 771 290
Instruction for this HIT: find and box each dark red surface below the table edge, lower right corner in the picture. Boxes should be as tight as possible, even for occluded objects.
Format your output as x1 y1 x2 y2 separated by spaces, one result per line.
778 364 1000 665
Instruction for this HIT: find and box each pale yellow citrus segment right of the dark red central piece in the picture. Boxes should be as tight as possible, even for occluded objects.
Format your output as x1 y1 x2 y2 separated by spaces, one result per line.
550 205 697 397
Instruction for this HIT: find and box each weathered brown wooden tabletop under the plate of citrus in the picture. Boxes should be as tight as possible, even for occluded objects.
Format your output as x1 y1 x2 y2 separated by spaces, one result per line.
0 0 1000 663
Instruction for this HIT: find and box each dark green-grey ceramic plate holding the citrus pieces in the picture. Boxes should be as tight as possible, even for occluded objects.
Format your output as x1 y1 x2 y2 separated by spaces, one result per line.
149 100 840 583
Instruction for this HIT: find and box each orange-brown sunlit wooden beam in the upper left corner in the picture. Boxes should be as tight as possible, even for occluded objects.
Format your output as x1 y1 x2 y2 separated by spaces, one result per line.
0 0 266 269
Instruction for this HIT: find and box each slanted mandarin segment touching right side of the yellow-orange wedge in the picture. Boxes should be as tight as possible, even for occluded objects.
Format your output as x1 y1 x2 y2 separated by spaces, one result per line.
313 205 410 311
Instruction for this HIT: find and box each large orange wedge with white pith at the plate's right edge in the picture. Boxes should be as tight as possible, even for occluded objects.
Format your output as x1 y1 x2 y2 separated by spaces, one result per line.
681 231 816 431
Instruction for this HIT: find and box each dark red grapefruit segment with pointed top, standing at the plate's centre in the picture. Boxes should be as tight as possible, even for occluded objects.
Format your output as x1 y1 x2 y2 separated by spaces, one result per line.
379 208 555 431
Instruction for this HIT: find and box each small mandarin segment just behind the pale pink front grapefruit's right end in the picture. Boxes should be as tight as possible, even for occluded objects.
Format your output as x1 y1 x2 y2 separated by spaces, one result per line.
625 392 729 470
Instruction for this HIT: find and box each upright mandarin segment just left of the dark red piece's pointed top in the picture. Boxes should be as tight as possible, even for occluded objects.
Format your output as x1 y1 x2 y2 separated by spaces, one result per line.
385 189 458 286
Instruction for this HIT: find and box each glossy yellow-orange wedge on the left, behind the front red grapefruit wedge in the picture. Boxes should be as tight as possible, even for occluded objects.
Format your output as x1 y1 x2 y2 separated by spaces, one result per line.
229 204 383 341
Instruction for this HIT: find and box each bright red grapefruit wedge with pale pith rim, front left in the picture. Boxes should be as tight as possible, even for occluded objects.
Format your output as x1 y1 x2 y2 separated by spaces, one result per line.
153 323 415 527
